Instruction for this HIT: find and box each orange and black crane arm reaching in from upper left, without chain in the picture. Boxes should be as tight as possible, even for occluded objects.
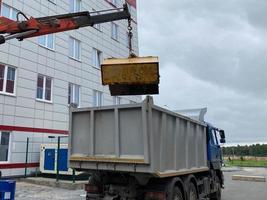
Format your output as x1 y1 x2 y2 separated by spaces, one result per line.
0 4 131 44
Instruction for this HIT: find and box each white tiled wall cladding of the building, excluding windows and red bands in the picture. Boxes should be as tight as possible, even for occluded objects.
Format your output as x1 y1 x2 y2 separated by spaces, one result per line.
0 0 141 175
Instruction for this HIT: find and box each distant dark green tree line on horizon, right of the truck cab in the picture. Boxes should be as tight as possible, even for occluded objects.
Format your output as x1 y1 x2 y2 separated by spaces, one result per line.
222 144 267 157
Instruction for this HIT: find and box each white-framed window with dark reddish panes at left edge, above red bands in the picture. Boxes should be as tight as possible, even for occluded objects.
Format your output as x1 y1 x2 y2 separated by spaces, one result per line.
0 64 16 94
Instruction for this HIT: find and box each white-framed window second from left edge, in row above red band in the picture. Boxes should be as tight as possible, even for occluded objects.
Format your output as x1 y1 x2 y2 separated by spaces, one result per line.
36 74 52 102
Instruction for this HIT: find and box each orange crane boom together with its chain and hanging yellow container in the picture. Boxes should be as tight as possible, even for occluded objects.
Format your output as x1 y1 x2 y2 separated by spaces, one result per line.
0 4 159 96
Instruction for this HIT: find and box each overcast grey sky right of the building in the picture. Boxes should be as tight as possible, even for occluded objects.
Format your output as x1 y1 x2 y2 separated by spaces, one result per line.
138 0 267 143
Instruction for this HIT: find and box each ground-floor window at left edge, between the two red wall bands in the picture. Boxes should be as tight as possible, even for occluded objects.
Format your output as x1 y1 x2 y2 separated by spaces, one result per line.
0 132 10 162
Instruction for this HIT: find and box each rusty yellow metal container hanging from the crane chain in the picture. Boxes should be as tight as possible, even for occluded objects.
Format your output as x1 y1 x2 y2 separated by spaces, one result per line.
101 57 159 96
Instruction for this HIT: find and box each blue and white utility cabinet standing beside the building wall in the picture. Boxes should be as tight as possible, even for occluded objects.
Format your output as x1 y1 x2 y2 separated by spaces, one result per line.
40 144 73 175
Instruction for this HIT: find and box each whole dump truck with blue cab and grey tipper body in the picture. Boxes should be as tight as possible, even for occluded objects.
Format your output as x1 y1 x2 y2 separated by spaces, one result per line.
69 97 225 200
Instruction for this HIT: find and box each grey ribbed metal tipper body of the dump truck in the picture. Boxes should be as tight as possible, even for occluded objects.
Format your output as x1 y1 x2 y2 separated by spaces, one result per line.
69 97 208 177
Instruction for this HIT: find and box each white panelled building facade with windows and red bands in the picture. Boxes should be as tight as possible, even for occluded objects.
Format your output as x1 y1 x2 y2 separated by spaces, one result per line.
0 0 141 176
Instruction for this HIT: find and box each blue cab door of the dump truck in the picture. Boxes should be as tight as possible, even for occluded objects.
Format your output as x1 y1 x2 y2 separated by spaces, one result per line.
208 128 222 169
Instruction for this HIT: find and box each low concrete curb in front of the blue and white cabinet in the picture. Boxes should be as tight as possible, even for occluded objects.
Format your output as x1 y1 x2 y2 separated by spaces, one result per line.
20 178 88 190
